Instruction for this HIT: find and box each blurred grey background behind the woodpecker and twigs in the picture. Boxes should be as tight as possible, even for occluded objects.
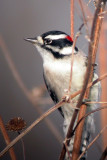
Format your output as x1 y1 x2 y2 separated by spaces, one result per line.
0 0 106 160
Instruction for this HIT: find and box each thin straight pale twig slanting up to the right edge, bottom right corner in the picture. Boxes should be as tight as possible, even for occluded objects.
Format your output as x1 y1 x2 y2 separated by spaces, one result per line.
77 125 107 160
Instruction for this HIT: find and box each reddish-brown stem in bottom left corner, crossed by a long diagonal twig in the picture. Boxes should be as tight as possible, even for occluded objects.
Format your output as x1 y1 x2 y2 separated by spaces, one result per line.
0 116 16 160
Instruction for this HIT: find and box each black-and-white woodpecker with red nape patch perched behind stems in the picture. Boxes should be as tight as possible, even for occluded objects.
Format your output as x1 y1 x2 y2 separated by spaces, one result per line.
25 30 101 160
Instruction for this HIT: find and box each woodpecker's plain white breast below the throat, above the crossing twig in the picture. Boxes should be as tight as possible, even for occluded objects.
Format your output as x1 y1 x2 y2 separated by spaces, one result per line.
43 52 86 100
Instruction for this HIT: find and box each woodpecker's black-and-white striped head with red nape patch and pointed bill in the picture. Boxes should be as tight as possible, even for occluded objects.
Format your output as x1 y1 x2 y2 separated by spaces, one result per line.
25 31 78 61
